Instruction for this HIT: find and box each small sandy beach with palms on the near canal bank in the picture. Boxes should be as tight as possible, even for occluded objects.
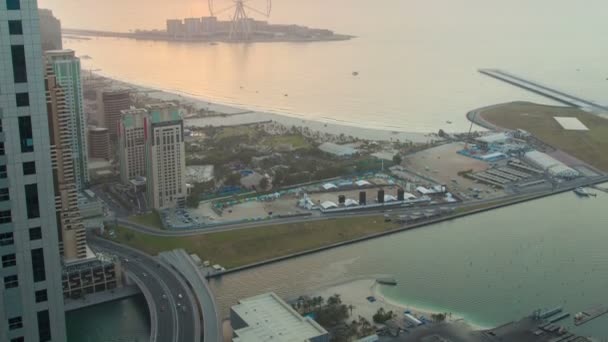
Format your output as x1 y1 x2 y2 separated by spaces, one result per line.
310 278 484 330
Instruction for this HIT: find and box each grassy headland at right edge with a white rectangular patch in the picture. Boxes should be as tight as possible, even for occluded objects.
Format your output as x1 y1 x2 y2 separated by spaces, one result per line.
480 102 608 171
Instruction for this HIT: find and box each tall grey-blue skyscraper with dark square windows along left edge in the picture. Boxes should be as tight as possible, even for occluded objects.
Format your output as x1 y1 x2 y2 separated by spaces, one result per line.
0 0 66 342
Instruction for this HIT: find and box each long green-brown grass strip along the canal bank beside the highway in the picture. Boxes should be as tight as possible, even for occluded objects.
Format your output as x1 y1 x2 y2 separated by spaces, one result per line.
109 216 397 268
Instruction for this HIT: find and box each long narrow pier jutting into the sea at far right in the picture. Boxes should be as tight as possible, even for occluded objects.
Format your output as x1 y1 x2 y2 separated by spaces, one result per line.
478 69 608 112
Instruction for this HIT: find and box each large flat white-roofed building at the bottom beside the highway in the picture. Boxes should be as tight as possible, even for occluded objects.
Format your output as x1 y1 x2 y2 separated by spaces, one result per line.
230 293 329 342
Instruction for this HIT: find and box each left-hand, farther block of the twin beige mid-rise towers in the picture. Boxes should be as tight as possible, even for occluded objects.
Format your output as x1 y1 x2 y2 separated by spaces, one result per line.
118 109 148 184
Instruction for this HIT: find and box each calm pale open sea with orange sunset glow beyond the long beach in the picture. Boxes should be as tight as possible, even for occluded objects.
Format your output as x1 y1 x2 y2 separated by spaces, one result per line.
58 0 608 132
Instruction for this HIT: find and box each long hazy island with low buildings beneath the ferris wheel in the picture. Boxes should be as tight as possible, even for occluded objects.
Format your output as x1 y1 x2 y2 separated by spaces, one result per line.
63 17 354 43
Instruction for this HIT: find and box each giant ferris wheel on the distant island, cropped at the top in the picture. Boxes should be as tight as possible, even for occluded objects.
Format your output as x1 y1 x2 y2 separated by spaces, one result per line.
207 0 272 40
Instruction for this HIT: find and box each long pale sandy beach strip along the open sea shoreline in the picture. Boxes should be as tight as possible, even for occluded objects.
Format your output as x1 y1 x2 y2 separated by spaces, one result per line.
97 75 440 143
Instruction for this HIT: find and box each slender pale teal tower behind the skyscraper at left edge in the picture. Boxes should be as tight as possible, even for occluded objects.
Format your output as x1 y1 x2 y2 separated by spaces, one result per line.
45 50 89 191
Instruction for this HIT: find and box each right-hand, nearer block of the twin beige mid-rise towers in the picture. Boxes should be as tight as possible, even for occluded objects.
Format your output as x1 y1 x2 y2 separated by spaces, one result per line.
144 103 187 210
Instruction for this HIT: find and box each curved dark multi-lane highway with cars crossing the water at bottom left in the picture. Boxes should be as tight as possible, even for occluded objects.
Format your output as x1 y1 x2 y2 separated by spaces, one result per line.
89 237 202 342
